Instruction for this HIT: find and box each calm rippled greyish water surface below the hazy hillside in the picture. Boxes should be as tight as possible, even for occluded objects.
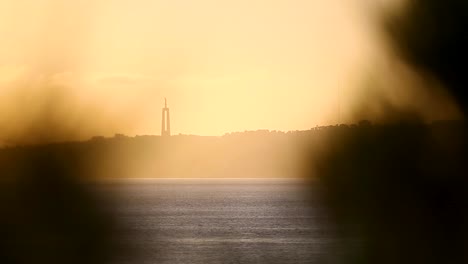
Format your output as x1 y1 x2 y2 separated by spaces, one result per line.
106 179 329 264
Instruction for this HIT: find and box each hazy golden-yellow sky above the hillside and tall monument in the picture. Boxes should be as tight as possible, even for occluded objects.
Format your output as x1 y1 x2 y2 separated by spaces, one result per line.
0 0 456 144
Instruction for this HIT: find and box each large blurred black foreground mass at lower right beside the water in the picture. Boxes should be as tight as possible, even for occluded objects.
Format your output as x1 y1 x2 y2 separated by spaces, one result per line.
317 122 468 264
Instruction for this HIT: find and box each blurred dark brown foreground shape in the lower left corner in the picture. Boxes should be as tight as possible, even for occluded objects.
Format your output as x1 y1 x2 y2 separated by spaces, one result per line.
0 146 121 264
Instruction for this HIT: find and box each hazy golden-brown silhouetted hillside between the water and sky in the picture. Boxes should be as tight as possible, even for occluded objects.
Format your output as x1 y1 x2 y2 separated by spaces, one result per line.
0 122 462 178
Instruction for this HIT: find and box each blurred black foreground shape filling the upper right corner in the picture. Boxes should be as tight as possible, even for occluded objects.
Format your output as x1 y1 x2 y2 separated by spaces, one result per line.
384 0 468 113
